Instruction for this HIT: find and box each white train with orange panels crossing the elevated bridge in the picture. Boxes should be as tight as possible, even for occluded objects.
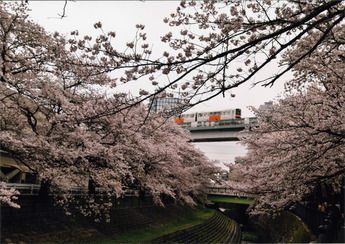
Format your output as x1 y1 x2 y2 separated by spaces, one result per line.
174 108 241 124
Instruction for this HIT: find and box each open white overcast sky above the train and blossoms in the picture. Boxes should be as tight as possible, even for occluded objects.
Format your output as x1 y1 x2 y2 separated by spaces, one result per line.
29 1 289 117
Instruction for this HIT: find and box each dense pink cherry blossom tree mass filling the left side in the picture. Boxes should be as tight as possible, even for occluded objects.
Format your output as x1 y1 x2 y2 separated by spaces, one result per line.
0 3 219 218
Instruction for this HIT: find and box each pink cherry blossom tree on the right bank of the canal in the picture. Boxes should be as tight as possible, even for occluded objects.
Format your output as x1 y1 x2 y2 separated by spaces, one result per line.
229 22 345 214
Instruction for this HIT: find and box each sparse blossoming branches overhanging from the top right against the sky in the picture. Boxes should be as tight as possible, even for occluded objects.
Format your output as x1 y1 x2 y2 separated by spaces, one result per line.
62 0 344 112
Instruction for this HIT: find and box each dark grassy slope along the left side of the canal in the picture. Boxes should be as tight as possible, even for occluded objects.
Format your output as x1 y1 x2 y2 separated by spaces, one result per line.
0 205 215 244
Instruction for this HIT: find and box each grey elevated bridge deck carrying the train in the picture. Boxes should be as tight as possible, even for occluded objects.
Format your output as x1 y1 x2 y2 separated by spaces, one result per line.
179 117 258 142
